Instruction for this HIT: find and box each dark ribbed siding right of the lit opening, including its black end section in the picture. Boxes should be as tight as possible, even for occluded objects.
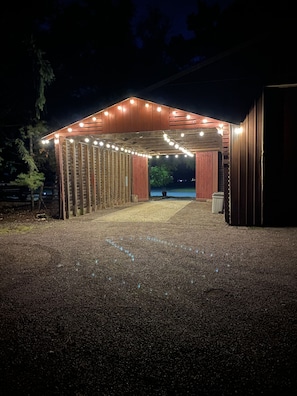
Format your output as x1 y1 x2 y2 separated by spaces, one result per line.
229 87 297 226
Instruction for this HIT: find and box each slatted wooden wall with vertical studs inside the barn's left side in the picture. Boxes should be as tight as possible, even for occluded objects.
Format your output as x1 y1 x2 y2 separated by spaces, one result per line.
58 139 132 218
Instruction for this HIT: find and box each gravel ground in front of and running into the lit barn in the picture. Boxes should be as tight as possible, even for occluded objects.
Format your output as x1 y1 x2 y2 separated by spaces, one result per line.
0 200 297 396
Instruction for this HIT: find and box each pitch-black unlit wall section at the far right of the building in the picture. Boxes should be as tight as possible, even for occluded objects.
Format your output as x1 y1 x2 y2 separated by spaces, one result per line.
263 87 297 226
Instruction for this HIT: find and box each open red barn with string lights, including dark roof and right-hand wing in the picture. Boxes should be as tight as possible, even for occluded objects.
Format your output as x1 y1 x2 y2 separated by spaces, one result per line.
44 26 297 226
